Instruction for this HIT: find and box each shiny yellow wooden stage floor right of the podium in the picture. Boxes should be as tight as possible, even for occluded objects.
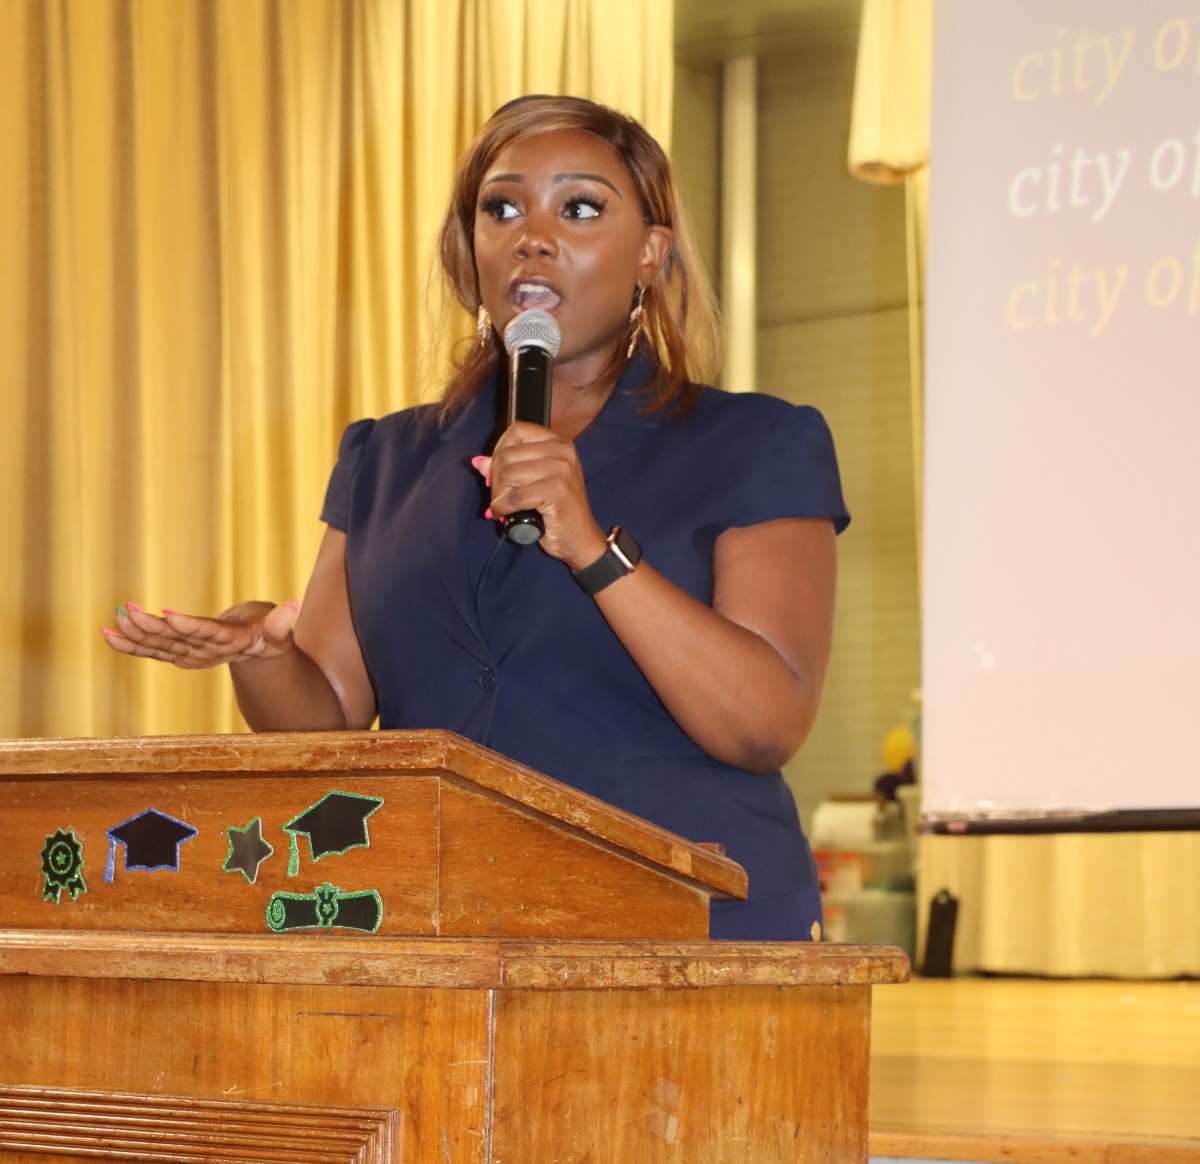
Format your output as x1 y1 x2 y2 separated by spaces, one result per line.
870 978 1200 1164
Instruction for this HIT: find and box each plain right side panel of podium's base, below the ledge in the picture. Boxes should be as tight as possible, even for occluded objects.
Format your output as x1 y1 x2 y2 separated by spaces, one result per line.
493 986 870 1164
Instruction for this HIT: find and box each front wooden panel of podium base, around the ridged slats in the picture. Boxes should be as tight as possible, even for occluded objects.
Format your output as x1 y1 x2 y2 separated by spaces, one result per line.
0 976 490 1164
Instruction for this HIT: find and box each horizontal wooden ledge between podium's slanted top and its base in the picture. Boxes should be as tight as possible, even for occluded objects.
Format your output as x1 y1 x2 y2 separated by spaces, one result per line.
0 930 908 990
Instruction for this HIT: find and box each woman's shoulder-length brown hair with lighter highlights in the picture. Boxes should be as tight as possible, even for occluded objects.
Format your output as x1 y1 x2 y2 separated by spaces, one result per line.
438 96 720 414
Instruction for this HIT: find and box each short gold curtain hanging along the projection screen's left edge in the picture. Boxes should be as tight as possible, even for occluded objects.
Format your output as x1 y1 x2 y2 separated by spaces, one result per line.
850 0 934 556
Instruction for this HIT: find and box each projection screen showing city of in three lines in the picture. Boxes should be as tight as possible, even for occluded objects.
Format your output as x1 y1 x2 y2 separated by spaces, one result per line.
922 0 1200 827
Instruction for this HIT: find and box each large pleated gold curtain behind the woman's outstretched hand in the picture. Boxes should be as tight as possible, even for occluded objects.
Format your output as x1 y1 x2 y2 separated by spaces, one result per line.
0 0 673 736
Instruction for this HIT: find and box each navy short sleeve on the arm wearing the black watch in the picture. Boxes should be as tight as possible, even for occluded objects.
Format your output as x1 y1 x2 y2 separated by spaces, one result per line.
731 397 850 533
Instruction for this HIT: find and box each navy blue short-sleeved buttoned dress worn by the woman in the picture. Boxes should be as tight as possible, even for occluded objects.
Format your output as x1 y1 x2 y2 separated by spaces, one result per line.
322 359 850 940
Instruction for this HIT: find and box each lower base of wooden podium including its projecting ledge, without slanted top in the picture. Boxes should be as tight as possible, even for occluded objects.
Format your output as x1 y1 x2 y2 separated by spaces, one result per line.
0 930 907 1164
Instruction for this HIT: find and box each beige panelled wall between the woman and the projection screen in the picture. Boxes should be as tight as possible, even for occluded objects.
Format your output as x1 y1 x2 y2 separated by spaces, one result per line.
673 43 919 823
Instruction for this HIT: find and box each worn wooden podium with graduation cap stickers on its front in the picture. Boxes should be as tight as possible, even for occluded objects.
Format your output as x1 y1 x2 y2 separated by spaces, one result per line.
0 732 908 1164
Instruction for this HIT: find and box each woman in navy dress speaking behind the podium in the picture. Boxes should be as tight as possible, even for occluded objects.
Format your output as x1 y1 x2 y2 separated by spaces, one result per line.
104 97 848 940
